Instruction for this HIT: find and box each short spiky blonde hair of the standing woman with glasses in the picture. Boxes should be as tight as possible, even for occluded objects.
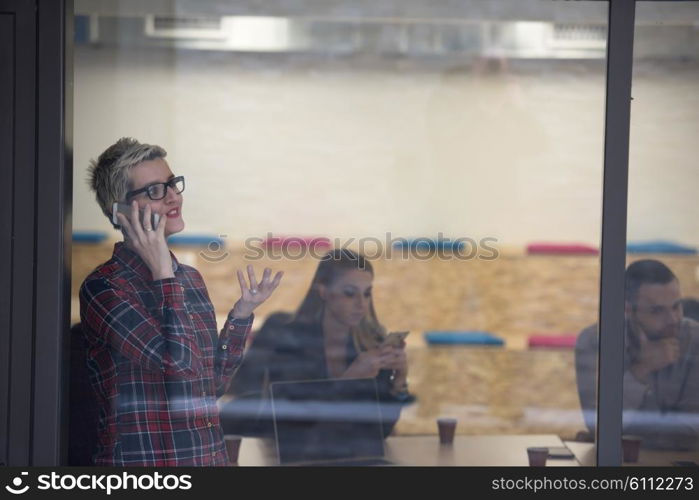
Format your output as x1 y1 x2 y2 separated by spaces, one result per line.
87 137 167 228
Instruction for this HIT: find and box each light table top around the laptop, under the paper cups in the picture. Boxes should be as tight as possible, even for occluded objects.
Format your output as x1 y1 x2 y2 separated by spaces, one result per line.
238 434 580 467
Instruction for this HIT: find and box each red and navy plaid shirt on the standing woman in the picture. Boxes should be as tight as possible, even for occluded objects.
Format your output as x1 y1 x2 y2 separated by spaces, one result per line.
80 243 252 466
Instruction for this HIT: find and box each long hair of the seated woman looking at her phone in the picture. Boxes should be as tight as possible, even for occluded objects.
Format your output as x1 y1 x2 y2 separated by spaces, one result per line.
294 248 386 352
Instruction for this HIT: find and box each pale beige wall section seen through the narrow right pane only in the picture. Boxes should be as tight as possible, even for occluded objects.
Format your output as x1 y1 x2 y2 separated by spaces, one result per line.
628 62 699 245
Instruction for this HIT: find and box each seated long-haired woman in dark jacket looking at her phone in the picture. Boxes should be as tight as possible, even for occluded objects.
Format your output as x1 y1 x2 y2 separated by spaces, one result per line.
222 249 413 435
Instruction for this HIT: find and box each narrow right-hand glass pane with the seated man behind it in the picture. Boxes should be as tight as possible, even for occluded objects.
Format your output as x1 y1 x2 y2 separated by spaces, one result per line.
623 2 699 465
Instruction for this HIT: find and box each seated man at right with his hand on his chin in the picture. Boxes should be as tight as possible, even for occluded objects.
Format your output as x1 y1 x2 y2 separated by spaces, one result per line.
576 259 699 461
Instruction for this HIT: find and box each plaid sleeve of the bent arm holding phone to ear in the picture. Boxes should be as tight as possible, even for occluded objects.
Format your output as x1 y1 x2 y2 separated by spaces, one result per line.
80 278 202 379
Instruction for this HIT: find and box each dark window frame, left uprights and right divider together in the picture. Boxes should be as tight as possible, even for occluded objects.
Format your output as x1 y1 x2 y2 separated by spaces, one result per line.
0 0 684 466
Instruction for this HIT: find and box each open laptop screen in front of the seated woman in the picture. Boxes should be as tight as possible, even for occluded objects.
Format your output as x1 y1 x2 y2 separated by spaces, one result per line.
270 378 384 465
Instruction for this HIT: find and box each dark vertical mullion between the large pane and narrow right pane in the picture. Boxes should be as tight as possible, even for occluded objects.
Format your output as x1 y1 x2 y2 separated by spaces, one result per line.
597 0 636 466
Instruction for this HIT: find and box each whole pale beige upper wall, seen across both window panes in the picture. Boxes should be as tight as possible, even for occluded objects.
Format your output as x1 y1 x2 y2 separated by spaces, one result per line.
73 47 699 245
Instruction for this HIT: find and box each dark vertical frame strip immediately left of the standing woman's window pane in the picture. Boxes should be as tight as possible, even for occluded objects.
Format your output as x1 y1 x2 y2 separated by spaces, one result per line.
31 0 73 466
